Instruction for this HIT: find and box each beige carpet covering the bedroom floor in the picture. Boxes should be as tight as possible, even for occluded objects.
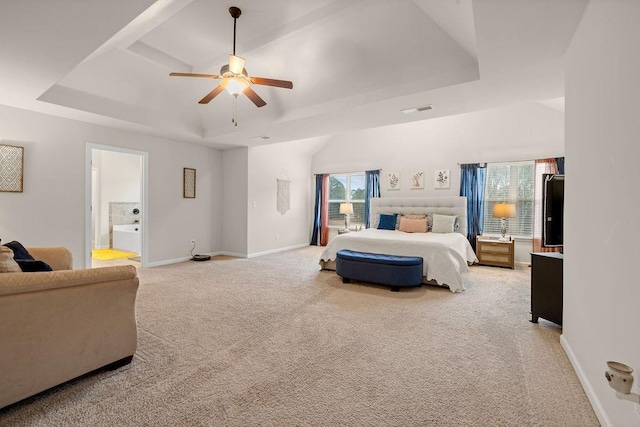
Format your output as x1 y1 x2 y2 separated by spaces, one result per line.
0 247 598 427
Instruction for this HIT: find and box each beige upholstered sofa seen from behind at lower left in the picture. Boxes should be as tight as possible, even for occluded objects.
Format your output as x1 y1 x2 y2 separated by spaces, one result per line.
0 247 138 408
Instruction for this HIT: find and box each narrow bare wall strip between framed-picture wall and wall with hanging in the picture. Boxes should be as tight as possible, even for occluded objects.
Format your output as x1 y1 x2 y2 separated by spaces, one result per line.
221 147 249 256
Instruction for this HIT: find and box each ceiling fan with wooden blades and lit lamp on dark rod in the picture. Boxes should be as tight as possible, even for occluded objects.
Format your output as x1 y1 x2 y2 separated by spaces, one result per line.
169 6 293 113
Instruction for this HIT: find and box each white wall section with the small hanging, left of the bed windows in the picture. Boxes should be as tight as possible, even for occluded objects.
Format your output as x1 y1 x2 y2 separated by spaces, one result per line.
248 141 313 256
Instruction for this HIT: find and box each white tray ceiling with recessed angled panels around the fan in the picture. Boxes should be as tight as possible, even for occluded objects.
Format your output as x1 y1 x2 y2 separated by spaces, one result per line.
0 0 588 148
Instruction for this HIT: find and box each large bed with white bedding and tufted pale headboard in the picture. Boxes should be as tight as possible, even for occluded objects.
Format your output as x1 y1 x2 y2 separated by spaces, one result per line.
319 197 478 292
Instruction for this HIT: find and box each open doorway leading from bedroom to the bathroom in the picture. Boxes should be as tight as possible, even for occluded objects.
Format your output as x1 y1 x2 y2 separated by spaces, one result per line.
85 144 148 268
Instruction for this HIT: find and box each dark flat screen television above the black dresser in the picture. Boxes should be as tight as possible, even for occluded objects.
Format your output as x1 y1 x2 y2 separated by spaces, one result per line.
542 174 564 248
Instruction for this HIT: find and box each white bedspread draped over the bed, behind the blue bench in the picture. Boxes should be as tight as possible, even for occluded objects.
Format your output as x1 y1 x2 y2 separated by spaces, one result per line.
320 228 478 292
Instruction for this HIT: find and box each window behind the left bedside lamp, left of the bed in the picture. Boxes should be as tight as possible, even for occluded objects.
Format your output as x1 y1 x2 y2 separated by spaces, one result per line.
329 172 365 226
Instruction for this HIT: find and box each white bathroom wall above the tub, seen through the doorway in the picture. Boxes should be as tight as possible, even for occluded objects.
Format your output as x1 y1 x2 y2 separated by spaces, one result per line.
92 150 142 248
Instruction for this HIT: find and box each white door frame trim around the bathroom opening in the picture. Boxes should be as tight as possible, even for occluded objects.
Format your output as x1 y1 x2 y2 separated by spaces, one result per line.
84 142 149 268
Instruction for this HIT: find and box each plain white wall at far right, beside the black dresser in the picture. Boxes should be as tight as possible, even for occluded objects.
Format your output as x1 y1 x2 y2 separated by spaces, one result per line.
562 0 640 426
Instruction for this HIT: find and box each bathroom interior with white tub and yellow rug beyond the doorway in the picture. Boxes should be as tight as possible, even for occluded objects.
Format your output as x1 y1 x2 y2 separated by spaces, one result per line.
91 149 143 268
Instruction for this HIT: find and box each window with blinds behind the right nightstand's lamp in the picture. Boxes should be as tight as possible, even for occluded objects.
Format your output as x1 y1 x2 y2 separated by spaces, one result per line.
482 162 535 237
